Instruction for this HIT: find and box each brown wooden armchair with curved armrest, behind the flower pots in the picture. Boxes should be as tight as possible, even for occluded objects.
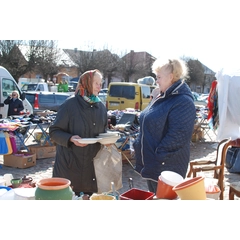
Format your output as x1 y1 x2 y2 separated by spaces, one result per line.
187 139 240 200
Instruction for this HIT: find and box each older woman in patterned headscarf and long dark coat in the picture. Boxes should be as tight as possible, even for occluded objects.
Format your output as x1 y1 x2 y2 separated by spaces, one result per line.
49 70 108 196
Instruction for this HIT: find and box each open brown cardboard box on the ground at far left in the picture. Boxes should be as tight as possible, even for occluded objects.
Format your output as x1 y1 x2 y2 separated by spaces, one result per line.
3 151 36 168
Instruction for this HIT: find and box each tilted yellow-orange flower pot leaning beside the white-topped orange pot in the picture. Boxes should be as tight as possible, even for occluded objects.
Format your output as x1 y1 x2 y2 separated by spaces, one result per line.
173 176 206 200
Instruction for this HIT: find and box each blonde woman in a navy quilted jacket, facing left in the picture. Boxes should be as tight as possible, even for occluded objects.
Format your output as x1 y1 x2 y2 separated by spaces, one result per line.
133 59 196 194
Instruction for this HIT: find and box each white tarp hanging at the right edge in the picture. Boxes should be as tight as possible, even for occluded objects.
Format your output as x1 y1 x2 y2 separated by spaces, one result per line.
216 71 240 141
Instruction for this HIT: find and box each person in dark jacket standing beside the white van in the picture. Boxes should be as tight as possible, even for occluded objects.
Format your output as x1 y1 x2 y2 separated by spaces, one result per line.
4 91 24 116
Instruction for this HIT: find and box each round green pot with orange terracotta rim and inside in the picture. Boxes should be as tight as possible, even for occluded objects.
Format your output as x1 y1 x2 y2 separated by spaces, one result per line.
35 178 74 200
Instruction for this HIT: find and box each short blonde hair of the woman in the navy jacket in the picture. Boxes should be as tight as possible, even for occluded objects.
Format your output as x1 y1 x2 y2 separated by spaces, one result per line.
152 59 188 82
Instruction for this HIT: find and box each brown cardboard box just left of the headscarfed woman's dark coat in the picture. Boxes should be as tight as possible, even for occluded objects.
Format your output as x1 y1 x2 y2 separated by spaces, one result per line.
28 145 56 159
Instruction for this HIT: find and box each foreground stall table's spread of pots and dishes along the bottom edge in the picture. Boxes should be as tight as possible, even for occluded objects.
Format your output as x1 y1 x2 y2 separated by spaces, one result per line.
0 171 220 200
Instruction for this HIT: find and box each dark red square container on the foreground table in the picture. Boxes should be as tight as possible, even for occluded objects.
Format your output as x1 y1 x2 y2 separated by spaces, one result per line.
119 188 155 200
